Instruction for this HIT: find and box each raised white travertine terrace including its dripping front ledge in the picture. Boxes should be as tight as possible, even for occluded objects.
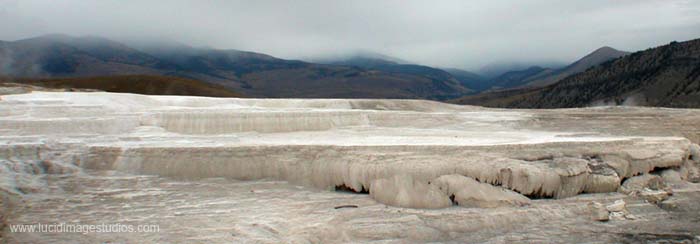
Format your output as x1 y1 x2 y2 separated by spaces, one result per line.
0 92 700 240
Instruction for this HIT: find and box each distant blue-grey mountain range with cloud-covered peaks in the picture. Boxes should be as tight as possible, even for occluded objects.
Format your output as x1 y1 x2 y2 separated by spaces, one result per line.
0 34 652 100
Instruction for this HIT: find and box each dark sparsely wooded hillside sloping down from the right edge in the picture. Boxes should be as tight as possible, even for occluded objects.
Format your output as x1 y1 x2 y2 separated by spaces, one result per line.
454 39 700 108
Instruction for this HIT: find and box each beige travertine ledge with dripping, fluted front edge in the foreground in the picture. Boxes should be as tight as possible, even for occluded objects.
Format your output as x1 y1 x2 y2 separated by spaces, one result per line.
0 138 697 208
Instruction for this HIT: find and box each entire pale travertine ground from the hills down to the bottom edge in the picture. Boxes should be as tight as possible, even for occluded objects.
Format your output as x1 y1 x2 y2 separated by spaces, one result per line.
0 92 700 243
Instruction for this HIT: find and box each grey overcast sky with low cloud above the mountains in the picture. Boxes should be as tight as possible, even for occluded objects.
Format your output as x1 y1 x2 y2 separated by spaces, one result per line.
0 0 700 70
